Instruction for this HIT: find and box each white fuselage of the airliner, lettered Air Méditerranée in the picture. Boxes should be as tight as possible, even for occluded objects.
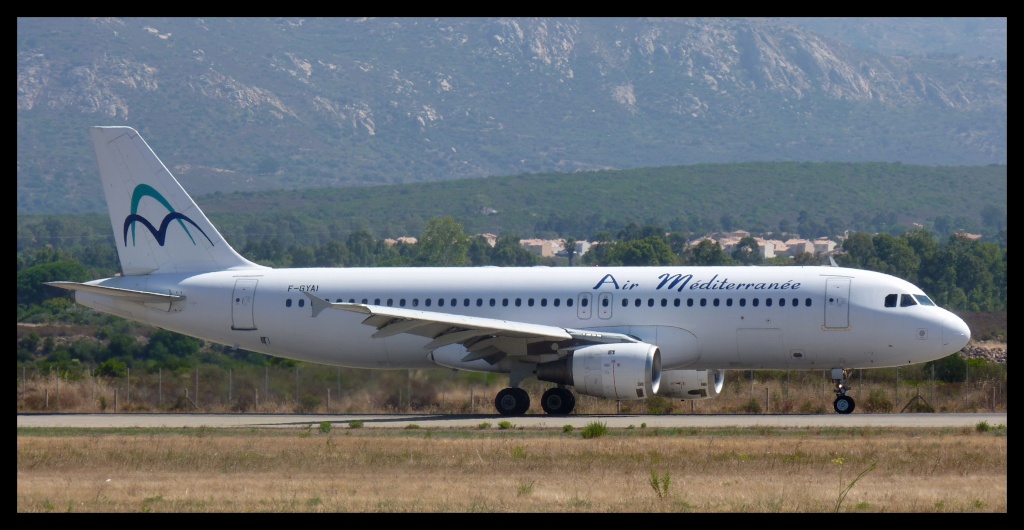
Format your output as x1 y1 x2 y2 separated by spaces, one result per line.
76 266 970 371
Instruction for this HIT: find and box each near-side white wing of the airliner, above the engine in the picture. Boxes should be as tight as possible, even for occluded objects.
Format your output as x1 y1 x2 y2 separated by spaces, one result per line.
305 293 639 362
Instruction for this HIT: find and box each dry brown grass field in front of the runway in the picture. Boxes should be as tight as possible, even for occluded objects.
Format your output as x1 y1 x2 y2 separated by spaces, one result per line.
16 418 1008 514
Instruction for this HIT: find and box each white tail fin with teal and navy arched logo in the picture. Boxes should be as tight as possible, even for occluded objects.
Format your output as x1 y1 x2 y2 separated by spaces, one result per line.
89 127 265 276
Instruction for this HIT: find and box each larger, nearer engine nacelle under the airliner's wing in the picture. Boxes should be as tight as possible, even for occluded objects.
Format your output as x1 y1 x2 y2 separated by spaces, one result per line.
537 343 662 400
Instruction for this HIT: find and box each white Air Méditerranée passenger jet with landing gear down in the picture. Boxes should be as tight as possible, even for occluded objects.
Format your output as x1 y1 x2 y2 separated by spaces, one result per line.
48 126 971 415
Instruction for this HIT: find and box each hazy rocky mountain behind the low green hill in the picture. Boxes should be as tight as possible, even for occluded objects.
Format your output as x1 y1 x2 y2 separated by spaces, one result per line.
17 17 1008 214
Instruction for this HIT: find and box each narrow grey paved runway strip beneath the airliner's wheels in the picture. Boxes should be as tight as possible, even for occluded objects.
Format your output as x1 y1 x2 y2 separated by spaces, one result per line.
17 412 1007 429
